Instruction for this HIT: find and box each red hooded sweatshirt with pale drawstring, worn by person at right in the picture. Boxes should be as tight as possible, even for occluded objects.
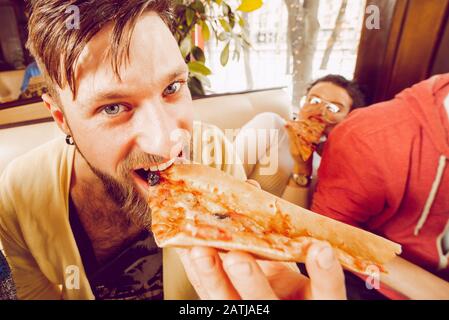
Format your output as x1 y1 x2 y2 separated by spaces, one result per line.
312 74 449 280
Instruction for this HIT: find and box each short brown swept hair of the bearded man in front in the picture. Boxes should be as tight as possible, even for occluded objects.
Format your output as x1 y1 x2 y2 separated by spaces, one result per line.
27 0 173 98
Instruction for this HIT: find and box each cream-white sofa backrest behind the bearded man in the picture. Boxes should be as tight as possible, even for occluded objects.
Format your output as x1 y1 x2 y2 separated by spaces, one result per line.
0 89 292 174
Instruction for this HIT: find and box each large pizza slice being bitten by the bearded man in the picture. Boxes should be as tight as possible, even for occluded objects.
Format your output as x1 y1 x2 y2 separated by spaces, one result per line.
149 164 401 273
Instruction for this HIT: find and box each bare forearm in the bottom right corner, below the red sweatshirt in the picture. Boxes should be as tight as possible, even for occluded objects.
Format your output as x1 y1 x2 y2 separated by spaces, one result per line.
380 257 449 300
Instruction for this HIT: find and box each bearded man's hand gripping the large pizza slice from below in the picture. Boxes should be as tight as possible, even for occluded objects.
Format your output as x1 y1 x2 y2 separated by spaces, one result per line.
178 244 346 300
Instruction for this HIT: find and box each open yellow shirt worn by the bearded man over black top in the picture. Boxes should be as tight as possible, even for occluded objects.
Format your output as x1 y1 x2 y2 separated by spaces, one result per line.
0 122 246 299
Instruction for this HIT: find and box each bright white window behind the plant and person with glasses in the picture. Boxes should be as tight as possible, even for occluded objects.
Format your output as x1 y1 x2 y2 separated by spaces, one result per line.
205 0 365 103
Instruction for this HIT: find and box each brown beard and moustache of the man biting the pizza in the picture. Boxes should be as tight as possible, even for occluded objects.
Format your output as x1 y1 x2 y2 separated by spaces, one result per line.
77 147 164 230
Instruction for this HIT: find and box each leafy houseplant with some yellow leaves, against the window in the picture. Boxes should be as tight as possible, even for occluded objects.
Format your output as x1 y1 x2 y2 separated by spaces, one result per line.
174 0 263 96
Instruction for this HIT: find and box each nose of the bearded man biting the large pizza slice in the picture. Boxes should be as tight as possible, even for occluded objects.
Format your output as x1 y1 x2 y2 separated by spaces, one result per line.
133 101 181 160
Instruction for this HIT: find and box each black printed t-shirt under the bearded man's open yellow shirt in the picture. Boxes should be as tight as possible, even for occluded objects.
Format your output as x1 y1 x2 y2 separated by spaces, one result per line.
69 198 164 300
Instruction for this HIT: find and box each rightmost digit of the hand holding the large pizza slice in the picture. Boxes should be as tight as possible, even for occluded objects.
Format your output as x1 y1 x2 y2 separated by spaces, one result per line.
306 243 346 300
